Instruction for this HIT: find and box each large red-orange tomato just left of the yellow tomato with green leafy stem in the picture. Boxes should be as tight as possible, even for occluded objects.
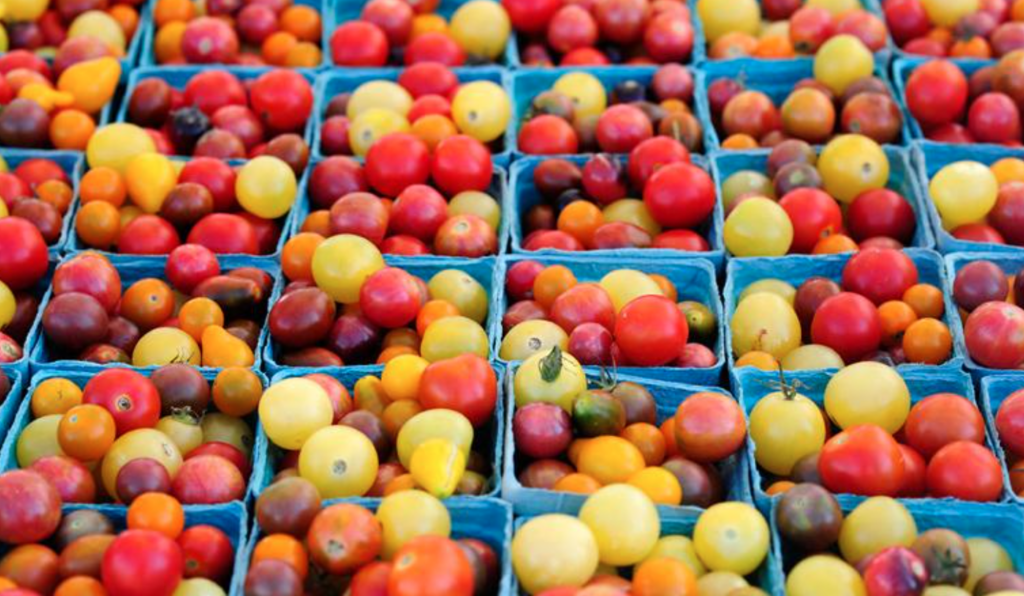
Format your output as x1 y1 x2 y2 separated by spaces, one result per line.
419 353 498 427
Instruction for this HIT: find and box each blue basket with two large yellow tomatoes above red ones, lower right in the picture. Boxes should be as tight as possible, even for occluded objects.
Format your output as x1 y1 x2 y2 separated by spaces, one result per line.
736 369 1010 512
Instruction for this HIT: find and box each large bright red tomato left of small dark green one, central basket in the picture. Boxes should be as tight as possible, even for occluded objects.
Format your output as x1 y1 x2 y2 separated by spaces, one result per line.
614 296 689 367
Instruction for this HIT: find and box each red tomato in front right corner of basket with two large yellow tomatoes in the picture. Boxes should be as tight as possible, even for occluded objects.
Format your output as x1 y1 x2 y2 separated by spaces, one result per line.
928 440 1002 502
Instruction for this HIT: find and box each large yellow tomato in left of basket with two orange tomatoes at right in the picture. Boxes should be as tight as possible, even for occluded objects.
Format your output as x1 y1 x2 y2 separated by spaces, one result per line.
730 292 802 359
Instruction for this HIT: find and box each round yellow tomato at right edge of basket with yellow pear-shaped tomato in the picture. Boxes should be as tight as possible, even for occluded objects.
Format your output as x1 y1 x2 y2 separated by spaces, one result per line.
234 156 298 219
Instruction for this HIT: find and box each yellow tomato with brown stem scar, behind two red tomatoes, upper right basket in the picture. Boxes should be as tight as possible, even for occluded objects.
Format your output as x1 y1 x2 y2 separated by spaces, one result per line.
818 134 889 204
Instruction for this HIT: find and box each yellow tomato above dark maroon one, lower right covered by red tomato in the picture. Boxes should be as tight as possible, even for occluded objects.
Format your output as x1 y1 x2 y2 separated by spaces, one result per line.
312 233 384 304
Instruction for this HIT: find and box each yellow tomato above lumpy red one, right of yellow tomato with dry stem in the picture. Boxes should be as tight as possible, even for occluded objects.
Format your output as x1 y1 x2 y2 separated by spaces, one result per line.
825 361 910 433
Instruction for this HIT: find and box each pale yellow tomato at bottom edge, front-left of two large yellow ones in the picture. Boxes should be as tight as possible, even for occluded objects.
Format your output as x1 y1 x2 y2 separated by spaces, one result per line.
512 513 598 594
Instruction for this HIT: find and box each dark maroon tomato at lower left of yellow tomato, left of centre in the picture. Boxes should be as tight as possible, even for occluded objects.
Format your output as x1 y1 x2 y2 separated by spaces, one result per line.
269 288 335 348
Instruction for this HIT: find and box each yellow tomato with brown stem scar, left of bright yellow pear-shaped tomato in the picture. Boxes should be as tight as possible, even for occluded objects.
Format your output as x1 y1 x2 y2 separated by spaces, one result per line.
299 426 378 499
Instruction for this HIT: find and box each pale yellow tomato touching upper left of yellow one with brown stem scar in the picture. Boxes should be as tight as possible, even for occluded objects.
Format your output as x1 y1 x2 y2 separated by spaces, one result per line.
259 378 334 450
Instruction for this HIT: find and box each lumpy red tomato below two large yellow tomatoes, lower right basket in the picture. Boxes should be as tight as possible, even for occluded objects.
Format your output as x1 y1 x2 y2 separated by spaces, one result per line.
818 424 903 497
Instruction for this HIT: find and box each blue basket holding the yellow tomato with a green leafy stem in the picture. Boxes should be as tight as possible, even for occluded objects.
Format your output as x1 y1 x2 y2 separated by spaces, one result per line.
502 363 751 517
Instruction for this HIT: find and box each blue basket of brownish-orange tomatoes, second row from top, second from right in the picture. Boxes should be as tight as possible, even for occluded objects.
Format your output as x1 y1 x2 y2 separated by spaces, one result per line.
696 59 909 150
